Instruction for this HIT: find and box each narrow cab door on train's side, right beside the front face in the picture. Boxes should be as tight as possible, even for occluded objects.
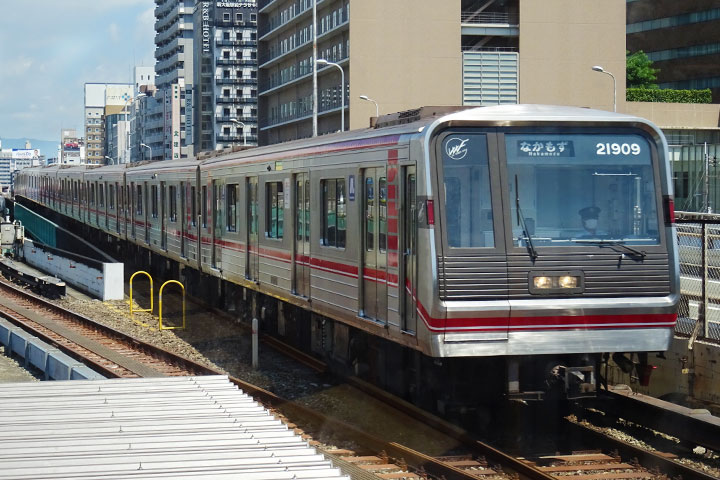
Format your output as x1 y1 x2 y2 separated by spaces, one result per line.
398 167 418 333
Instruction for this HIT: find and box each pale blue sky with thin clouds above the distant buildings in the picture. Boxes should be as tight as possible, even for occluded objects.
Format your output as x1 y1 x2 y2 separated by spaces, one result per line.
0 0 156 142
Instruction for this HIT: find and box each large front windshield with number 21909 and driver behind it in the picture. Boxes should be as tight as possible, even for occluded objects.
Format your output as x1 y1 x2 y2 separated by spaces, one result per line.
505 132 660 246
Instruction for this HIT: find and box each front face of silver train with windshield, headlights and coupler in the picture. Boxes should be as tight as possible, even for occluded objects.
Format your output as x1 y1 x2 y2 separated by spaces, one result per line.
418 105 679 399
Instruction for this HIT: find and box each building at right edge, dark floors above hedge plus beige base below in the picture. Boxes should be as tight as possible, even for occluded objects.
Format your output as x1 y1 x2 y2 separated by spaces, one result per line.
626 0 720 212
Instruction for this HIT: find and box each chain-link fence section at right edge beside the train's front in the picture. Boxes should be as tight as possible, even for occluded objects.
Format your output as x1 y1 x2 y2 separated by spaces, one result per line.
676 216 720 341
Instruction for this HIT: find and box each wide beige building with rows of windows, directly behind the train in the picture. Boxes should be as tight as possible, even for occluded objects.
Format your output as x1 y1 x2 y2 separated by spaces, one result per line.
258 0 625 144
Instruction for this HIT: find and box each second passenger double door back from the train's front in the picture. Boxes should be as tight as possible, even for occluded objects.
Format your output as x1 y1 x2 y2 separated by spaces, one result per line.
293 173 310 297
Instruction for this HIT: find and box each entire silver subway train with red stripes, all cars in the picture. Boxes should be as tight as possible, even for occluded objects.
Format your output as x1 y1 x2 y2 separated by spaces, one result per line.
14 105 679 408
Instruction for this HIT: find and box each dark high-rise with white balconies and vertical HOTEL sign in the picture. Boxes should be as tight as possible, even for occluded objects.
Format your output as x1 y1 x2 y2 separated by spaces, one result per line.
193 1 257 152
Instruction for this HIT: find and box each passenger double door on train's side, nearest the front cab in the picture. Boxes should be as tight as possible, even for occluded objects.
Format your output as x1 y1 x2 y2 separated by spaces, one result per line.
362 168 387 322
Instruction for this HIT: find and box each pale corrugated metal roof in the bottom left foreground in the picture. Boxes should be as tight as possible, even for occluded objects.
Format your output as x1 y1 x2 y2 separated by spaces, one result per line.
0 376 347 480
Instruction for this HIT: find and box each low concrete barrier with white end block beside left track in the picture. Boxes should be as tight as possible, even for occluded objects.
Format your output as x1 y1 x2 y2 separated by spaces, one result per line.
23 238 125 301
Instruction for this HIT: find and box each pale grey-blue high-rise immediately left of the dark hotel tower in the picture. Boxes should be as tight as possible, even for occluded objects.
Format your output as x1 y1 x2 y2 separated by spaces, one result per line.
150 0 195 160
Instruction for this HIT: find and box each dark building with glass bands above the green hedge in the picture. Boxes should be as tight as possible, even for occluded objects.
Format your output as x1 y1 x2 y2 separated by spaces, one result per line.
626 0 720 103
